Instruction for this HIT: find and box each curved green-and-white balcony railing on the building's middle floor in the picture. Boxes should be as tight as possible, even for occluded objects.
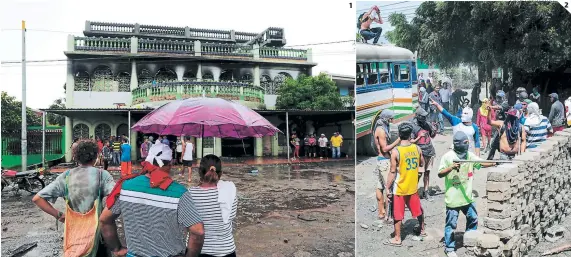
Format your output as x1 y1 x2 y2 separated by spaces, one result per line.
131 81 264 105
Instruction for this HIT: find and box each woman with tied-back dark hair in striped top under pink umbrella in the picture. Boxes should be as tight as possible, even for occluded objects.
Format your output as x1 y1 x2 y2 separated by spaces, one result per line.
190 154 238 257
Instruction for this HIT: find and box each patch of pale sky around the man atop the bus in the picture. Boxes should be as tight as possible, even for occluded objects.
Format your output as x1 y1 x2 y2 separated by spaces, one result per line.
353 1 423 43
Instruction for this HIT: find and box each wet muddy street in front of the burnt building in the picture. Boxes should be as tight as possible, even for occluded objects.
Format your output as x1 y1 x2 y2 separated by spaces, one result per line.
2 160 355 256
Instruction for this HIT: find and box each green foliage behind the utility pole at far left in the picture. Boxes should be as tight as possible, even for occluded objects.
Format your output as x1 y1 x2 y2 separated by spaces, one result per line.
2 91 42 135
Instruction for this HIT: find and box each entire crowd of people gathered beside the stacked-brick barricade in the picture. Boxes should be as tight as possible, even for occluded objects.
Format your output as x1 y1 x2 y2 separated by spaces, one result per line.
373 81 571 257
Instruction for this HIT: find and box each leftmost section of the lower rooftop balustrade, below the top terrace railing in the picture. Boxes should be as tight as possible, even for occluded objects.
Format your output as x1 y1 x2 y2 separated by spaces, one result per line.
74 37 131 52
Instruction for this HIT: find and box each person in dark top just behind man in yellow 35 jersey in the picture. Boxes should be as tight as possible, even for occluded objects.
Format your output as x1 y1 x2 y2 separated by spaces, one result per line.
411 107 436 200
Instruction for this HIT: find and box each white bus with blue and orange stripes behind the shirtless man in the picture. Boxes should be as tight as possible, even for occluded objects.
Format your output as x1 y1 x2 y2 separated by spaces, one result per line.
355 43 418 155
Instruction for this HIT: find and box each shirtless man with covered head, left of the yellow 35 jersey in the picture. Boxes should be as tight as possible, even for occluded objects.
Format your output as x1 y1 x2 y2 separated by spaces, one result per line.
373 109 400 220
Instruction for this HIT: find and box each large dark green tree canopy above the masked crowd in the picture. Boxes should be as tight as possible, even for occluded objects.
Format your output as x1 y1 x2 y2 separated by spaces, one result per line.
386 1 571 71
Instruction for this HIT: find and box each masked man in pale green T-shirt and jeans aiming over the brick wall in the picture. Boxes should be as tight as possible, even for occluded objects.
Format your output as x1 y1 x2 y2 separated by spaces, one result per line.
438 131 495 257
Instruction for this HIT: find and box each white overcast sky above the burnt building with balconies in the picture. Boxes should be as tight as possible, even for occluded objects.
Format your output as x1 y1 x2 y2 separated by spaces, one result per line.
0 0 355 108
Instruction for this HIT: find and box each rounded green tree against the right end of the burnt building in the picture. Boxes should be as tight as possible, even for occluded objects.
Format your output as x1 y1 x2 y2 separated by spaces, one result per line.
276 73 344 110
